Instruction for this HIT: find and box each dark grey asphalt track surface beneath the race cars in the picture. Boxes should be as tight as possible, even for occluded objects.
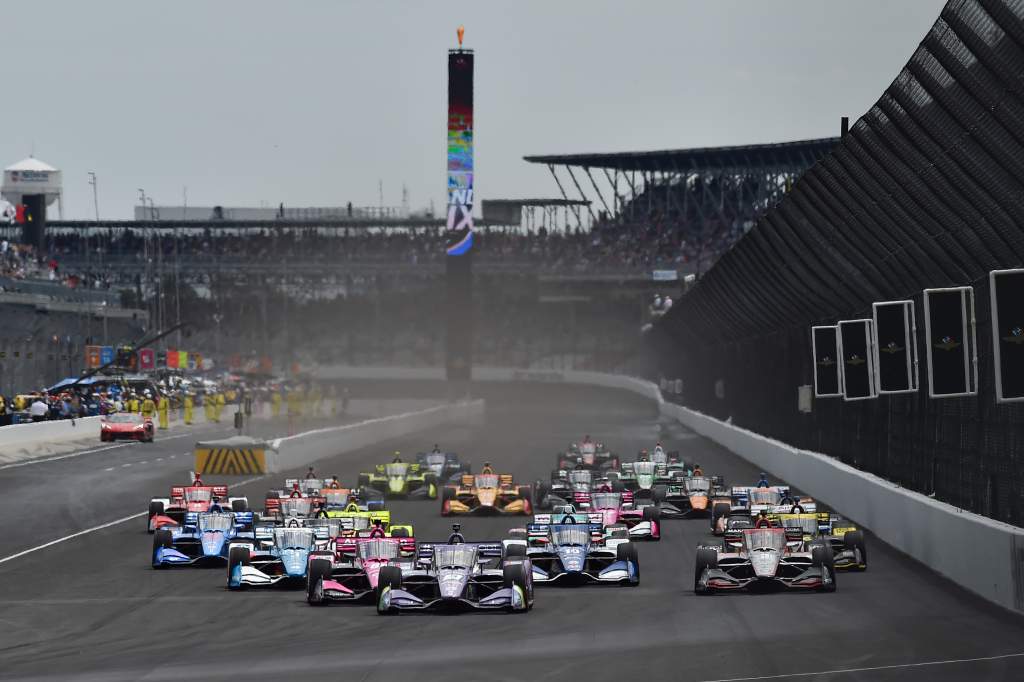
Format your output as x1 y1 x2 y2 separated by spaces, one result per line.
0 386 1024 682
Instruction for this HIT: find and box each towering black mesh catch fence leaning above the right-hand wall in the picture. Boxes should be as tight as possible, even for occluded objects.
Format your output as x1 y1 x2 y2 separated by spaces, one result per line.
651 1 1024 525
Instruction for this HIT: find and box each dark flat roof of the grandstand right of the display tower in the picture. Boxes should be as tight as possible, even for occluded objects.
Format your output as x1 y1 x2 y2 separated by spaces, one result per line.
523 137 839 171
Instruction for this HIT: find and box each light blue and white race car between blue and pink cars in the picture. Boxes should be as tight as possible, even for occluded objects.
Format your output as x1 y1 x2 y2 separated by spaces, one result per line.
227 519 338 590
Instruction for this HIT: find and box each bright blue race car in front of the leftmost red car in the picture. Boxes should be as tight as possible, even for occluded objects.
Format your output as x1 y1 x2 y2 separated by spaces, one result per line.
152 511 255 568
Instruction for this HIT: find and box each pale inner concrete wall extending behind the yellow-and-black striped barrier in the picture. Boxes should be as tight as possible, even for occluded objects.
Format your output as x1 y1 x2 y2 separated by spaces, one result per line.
267 400 484 472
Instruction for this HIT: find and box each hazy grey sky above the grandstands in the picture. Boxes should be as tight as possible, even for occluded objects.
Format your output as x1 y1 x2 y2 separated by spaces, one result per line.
0 0 943 218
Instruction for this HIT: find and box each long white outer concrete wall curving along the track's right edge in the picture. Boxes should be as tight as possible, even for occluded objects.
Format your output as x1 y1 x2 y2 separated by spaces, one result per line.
319 367 1024 613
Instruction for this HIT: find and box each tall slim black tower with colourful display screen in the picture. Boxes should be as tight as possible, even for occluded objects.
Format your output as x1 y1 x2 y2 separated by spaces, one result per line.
444 27 473 382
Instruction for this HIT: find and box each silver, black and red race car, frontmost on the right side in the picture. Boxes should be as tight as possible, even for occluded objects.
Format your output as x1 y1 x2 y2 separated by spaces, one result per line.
693 527 836 594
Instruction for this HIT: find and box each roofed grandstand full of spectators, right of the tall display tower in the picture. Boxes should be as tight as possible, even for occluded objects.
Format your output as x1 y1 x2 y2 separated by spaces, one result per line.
524 137 838 274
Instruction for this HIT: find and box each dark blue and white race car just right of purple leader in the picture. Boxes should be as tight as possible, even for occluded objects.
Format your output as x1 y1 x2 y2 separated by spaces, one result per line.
526 517 640 586
